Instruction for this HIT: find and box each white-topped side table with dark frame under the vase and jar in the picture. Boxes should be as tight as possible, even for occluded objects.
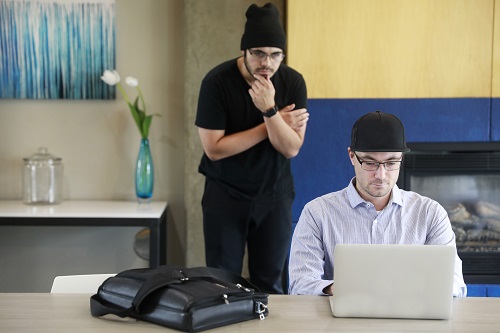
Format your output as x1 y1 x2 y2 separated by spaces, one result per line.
0 200 168 267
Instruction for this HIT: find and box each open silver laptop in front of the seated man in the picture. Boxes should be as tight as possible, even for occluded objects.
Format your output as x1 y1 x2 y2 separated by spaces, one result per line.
330 244 455 319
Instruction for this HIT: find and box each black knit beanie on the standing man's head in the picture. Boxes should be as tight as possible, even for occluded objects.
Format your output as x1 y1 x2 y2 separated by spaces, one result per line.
241 2 286 50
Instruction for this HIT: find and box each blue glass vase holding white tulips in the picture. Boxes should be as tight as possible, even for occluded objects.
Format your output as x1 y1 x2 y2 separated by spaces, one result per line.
135 138 155 203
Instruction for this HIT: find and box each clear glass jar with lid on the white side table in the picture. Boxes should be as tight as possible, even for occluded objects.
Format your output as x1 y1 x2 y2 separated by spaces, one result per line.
23 147 63 205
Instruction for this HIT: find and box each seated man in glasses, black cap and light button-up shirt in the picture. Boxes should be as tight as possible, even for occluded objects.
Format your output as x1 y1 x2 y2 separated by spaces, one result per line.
289 111 467 297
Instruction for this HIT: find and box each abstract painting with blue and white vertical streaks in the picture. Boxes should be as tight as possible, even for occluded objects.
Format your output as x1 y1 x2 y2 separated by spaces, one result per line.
0 0 115 99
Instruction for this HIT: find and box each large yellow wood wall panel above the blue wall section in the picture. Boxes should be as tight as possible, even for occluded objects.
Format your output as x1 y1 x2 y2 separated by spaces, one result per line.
287 0 494 98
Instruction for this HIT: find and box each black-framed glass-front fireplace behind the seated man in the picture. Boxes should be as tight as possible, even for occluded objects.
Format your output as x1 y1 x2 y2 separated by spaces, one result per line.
398 142 500 284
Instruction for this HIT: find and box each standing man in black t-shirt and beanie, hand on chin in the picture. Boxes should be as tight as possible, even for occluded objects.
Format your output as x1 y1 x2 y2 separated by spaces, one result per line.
195 3 308 293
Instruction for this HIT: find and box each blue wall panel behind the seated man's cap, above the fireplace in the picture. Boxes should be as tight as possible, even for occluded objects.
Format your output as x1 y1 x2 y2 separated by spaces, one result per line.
292 98 490 221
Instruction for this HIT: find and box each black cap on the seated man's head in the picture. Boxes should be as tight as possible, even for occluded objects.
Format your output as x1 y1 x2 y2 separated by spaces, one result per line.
350 111 410 152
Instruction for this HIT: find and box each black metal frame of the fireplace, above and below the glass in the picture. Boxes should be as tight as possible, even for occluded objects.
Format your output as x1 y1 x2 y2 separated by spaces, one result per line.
397 142 500 284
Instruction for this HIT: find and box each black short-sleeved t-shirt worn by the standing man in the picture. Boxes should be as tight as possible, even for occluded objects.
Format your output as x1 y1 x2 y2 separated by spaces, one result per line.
195 59 307 201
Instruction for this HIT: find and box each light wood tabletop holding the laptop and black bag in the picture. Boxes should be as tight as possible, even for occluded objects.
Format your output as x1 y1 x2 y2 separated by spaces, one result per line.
0 294 500 333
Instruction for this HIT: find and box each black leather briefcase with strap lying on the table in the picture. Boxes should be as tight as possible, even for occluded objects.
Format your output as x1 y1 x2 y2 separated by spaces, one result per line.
90 266 268 332
